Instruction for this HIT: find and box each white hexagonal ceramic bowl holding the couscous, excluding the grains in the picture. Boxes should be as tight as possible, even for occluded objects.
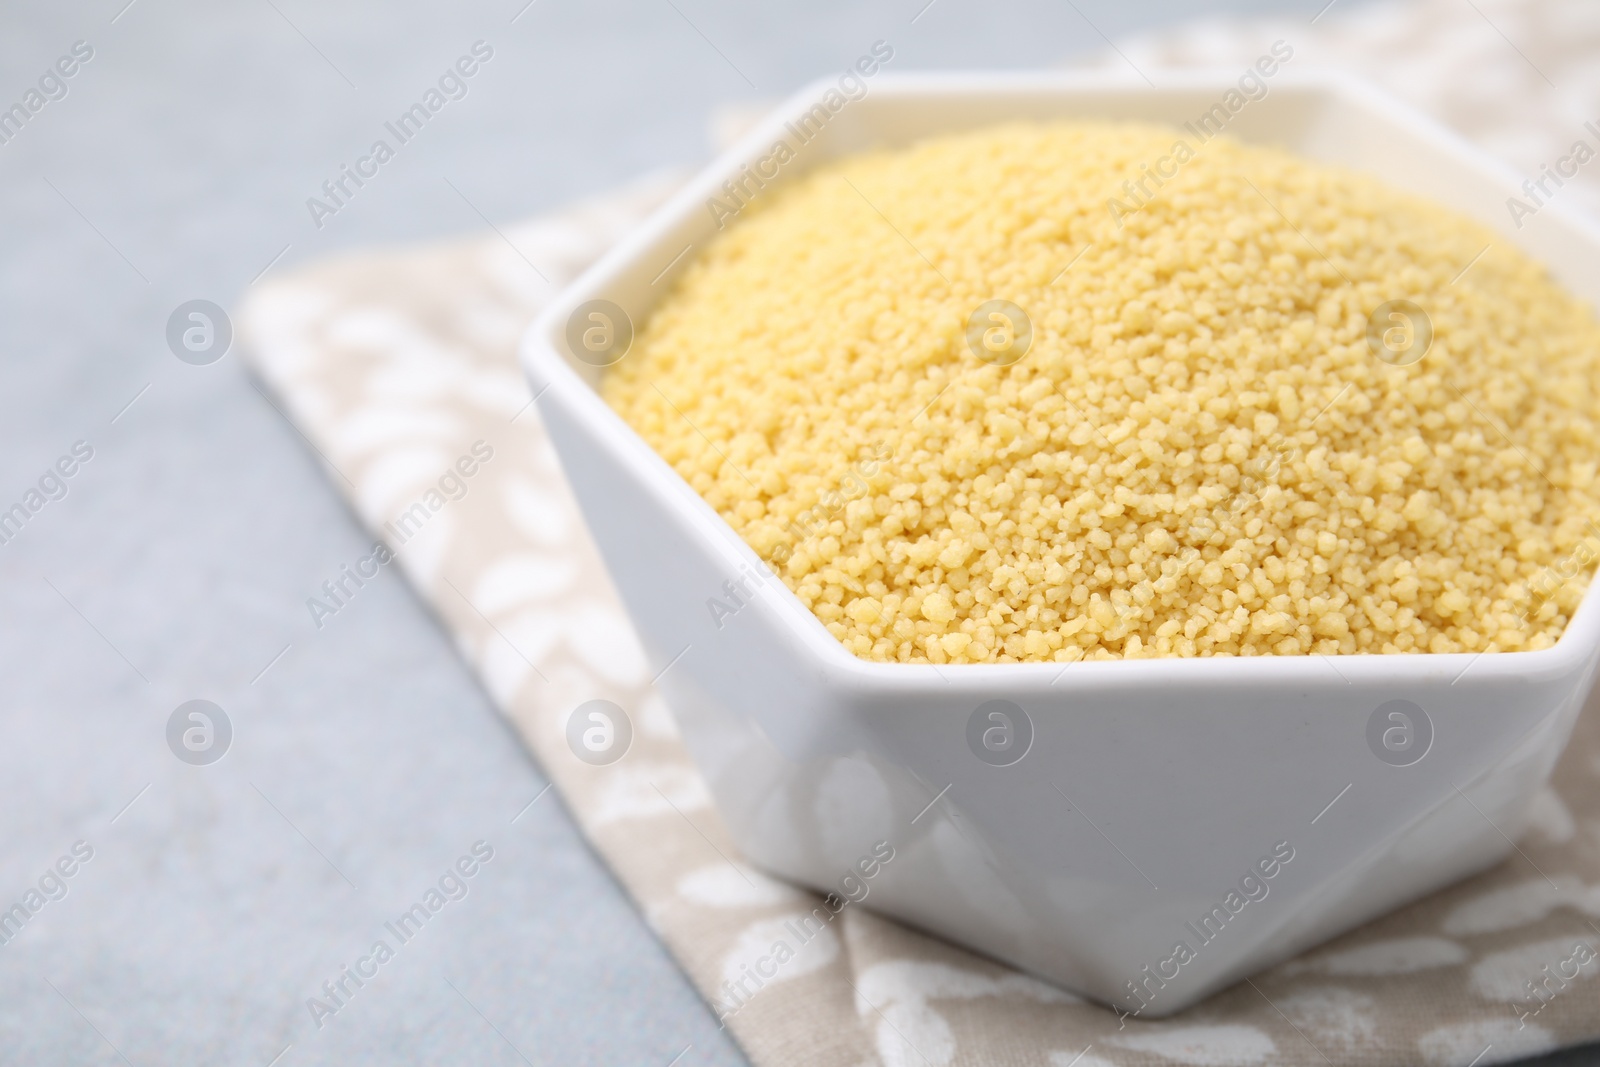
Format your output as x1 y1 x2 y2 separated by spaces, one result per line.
523 69 1600 1017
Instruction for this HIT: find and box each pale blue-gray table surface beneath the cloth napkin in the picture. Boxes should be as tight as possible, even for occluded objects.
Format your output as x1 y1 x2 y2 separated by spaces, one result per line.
0 0 1593 1067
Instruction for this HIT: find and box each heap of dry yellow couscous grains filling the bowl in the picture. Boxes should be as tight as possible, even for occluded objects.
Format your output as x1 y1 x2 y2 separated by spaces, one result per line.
603 123 1600 664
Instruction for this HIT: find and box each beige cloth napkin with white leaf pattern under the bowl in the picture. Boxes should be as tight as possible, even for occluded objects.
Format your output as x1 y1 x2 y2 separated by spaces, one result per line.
240 0 1600 1067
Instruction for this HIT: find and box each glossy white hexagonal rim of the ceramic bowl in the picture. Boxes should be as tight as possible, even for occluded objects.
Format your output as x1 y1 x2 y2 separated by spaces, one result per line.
518 67 1600 696
